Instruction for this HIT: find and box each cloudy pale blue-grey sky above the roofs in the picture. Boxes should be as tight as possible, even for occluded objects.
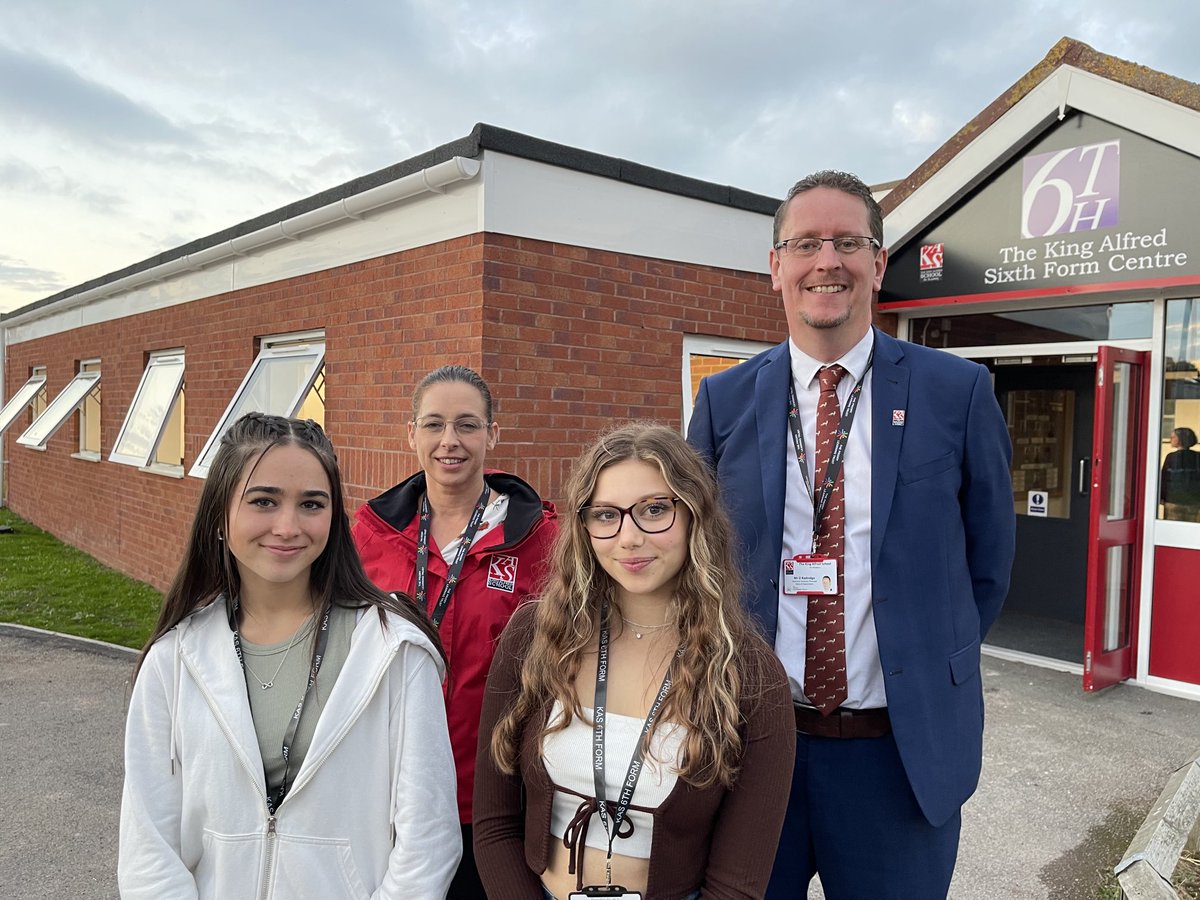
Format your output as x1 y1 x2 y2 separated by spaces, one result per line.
0 0 1200 311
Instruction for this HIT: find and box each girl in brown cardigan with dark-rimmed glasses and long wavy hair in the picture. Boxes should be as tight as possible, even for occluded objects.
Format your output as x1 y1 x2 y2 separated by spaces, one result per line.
474 424 796 900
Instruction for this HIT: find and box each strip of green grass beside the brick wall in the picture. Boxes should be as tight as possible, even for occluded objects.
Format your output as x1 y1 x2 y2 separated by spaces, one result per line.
0 509 162 648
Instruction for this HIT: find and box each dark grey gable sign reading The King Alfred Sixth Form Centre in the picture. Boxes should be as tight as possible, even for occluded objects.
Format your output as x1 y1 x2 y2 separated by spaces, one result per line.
897 116 1200 304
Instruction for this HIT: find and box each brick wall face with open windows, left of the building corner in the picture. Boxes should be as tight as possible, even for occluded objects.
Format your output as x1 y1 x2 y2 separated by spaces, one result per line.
4 235 482 588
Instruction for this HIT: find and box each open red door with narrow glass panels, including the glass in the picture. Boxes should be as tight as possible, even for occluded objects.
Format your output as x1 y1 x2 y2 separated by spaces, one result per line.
1084 346 1150 691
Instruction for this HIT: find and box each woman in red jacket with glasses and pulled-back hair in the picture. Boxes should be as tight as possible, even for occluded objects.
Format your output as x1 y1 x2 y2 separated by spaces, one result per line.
353 366 556 900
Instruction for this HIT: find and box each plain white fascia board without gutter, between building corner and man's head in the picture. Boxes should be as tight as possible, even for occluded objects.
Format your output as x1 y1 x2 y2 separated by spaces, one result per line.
484 150 772 274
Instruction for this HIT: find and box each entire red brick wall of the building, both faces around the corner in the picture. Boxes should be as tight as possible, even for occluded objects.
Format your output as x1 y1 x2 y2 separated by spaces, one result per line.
4 234 785 588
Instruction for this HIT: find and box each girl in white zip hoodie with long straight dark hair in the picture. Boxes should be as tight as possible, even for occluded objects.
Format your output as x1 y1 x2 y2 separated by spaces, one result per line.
118 413 462 900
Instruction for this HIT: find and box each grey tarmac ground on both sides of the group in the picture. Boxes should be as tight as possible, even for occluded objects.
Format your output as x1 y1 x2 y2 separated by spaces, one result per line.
0 625 1200 900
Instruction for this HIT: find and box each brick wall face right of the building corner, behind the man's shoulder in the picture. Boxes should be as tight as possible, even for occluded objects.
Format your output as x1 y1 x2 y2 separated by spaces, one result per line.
480 234 786 498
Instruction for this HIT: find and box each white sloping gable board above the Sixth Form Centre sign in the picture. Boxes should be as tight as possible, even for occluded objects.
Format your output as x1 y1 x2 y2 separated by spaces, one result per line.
883 66 1200 247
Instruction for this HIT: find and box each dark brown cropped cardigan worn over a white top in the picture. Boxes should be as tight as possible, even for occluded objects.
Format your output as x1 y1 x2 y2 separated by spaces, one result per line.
474 604 796 900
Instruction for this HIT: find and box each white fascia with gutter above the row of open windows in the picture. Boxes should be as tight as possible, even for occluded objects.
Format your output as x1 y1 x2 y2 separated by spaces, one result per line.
2 157 482 346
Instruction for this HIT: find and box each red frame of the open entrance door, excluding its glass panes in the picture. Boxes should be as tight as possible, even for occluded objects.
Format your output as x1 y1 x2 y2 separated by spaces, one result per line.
1084 346 1150 691
